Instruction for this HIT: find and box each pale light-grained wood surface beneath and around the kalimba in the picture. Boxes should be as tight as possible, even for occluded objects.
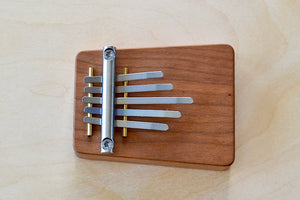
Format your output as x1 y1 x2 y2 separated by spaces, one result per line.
0 0 300 200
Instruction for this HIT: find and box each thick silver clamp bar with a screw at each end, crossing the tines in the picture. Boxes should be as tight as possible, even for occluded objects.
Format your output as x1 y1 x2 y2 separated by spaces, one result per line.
101 46 116 154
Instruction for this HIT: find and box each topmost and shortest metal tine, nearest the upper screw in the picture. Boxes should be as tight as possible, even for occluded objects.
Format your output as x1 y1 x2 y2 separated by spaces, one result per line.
84 71 164 83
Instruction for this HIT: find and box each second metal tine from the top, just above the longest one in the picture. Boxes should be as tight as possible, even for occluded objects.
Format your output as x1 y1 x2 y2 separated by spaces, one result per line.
84 83 173 94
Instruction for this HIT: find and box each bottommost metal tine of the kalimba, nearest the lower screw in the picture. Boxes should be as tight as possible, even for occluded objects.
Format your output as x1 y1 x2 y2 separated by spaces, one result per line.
83 117 169 131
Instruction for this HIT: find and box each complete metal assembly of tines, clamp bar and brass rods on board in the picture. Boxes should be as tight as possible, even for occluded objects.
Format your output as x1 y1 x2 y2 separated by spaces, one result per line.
82 46 193 154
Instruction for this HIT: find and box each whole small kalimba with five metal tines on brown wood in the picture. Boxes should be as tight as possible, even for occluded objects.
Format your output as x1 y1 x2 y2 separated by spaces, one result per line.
74 45 235 170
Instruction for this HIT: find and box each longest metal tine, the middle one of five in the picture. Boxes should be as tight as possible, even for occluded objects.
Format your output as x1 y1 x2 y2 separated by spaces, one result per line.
82 97 193 105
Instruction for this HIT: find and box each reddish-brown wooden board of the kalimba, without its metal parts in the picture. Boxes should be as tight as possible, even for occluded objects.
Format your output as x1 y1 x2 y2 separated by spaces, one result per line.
74 45 235 170
